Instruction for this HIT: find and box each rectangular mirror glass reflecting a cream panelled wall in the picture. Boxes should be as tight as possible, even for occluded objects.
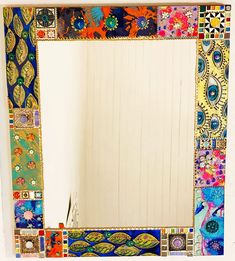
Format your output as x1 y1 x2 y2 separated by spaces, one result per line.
39 40 196 227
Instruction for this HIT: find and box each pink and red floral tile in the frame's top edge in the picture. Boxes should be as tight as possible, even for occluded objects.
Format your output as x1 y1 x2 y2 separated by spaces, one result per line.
157 6 198 38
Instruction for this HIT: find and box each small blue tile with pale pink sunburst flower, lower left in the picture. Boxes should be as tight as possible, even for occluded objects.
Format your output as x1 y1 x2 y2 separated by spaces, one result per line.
15 200 43 229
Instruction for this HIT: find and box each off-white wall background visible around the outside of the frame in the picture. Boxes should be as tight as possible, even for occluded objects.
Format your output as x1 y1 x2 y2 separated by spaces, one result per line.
0 0 235 260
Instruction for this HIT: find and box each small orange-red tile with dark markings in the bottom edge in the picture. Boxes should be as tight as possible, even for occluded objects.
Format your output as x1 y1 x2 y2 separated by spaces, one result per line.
46 231 63 257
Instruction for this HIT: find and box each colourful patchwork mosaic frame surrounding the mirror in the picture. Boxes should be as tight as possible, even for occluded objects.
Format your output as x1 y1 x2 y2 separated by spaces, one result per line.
4 4 231 257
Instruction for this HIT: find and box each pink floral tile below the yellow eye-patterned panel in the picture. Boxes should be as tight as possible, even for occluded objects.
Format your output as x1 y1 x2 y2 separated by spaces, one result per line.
195 150 226 187
